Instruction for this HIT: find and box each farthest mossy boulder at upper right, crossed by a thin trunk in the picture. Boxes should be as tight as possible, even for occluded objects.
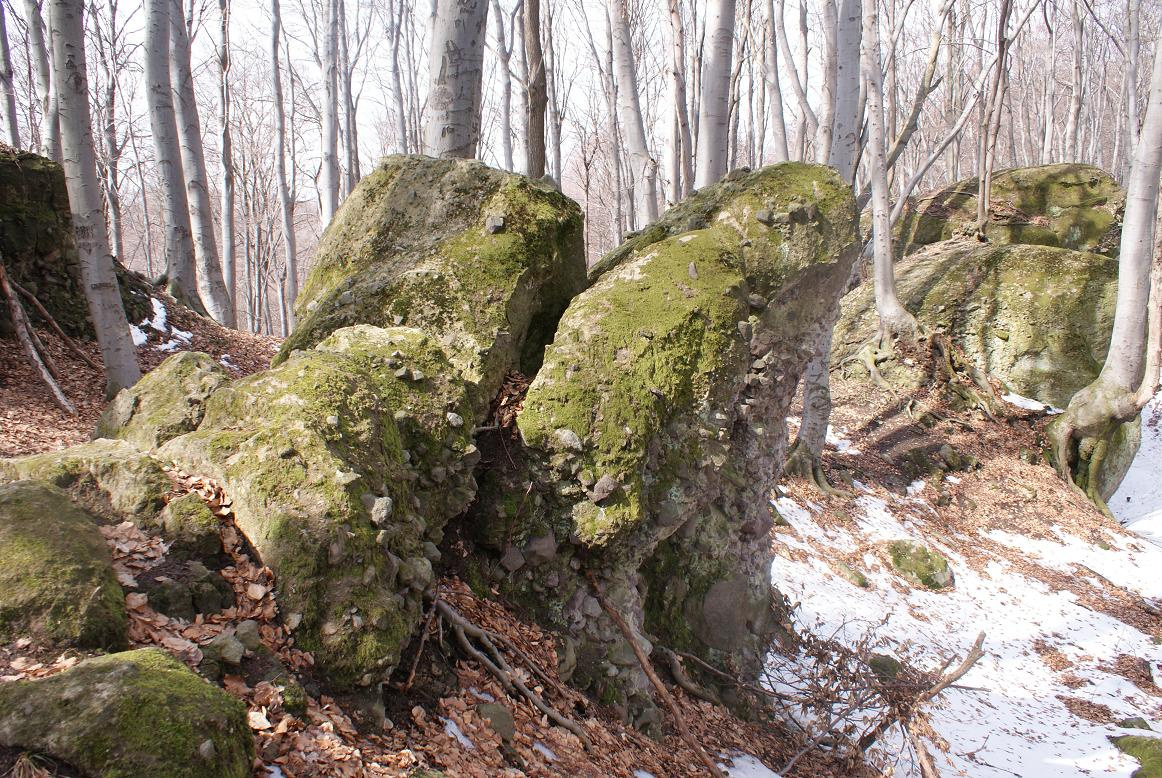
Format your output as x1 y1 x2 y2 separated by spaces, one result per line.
895 163 1126 257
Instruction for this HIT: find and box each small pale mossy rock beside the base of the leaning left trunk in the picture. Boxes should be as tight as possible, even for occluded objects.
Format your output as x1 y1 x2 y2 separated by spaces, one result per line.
95 351 230 451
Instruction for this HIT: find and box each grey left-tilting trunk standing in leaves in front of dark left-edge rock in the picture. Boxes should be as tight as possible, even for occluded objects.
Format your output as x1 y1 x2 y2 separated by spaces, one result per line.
49 0 141 396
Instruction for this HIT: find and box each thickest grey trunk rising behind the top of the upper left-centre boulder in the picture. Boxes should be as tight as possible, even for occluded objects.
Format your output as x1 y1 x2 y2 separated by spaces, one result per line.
426 0 488 159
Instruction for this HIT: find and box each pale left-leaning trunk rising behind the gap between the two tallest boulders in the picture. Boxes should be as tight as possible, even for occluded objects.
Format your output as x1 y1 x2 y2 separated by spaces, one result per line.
609 0 658 229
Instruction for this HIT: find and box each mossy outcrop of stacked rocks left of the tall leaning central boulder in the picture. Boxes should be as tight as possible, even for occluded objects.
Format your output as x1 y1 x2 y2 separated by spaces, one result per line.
90 157 586 687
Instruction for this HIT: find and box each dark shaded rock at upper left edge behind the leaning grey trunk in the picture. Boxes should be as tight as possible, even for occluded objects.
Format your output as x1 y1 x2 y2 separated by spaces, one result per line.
0 151 149 337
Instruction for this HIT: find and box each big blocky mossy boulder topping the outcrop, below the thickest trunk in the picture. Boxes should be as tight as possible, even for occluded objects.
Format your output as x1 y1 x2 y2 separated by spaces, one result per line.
275 156 586 416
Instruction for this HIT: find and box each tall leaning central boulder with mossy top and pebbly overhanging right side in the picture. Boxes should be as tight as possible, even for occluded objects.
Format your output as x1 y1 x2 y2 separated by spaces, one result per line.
469 164 855 709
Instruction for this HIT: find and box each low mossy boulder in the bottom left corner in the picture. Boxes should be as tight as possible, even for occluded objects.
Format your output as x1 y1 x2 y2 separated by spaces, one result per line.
0 648 254 778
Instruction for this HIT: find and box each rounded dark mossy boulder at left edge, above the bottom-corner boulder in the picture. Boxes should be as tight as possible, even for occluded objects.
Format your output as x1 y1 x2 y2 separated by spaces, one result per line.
0 481 128 650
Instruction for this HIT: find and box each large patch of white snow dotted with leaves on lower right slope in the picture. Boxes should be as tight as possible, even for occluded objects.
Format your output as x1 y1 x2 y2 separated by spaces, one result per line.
772 476 1162 778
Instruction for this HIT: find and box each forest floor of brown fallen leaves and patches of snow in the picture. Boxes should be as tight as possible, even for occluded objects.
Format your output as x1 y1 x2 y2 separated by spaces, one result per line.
0 298 1162 778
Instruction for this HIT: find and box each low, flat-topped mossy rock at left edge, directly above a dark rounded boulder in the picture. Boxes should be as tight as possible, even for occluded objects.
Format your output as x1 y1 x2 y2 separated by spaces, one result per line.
0 440 173 526
